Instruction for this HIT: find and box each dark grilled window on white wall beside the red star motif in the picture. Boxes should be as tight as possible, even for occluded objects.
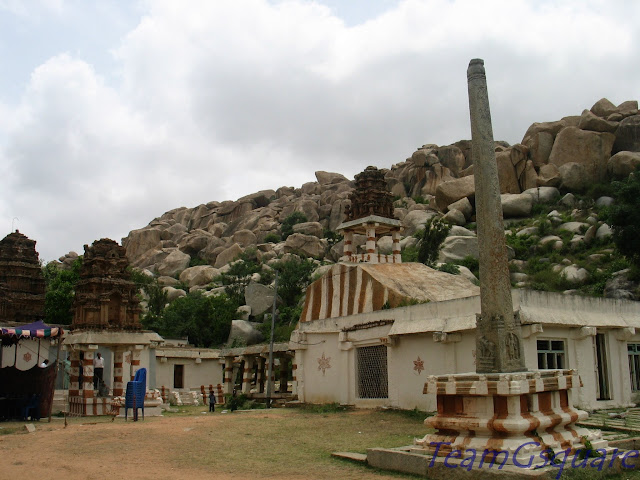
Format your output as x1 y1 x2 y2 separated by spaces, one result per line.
356 345 389 398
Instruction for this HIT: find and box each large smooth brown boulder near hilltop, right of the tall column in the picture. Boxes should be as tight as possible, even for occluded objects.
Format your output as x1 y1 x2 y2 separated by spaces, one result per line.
549 127 615 183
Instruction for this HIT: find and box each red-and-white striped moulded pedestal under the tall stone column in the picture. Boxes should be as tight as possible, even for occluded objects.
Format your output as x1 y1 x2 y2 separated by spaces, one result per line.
414 370 607 464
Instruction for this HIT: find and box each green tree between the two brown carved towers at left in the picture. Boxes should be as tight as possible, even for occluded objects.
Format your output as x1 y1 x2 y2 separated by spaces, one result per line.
42 257 82 325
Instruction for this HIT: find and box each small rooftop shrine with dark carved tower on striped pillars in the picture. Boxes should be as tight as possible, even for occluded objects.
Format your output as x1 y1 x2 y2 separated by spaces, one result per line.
337 167 402 263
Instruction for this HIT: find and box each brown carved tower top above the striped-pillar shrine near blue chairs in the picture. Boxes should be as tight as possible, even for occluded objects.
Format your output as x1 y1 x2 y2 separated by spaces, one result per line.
72 238 141 330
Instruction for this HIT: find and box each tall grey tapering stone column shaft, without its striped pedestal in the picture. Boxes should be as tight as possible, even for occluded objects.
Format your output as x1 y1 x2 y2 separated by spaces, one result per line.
467 59 526 373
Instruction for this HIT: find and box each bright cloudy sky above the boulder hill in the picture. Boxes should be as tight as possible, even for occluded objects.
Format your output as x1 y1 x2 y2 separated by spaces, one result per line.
0 0 640 262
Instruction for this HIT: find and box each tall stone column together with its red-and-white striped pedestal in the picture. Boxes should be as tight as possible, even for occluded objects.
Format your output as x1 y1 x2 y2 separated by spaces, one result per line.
408 59 607 468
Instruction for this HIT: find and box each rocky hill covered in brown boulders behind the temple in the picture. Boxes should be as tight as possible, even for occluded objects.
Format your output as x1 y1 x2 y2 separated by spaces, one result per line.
61 99 640 312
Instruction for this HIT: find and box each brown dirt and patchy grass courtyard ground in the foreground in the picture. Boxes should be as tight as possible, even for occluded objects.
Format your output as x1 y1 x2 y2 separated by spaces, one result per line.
0 407 420 480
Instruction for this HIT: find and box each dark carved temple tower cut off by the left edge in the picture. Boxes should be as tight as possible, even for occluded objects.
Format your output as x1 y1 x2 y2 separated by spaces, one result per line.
0 230 45 324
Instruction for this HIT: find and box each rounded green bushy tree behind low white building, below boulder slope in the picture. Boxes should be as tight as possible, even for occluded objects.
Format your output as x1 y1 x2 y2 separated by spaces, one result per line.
152 291 238 347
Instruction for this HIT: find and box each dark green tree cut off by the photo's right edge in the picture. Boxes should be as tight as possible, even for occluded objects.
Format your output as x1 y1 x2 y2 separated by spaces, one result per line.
604 169 640 268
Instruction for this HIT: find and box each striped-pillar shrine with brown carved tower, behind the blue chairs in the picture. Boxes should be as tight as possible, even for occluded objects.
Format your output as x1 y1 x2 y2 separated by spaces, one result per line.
65 238 162 415
